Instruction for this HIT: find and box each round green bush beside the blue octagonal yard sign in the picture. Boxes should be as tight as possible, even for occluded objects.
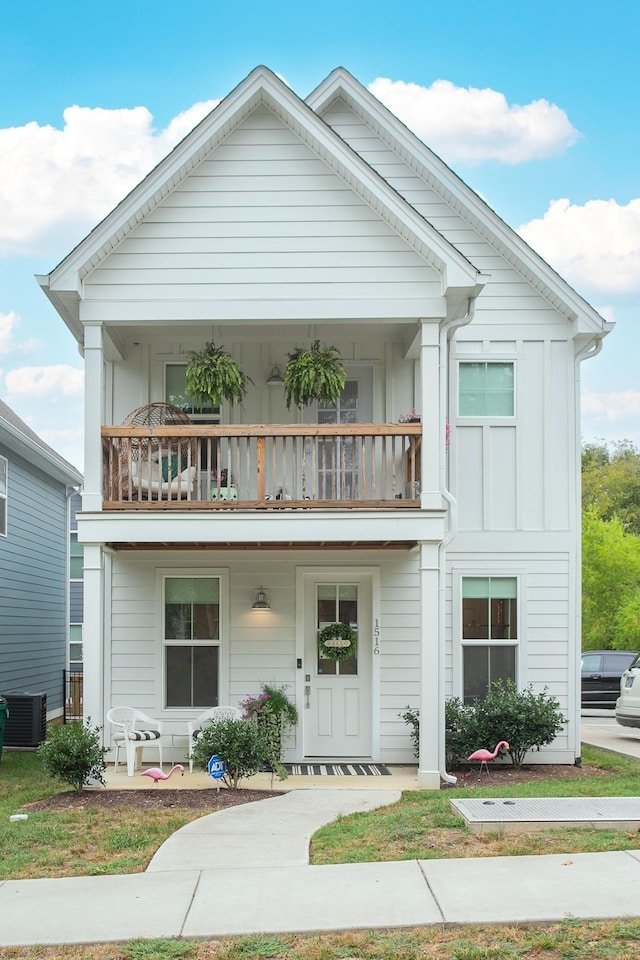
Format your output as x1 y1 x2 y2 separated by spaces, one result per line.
193 720 273 790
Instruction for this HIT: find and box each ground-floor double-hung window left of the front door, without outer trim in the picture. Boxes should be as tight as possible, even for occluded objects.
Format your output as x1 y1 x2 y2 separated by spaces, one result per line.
162 574 221 710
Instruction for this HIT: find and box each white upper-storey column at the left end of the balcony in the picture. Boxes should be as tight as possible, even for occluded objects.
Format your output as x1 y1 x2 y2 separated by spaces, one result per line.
82 323 104 510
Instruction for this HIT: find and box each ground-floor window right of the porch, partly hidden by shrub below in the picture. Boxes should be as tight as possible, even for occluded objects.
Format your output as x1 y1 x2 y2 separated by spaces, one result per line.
462 577 519 703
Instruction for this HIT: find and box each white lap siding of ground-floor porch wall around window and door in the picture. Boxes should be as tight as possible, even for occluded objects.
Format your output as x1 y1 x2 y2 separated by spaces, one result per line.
110 554 421 762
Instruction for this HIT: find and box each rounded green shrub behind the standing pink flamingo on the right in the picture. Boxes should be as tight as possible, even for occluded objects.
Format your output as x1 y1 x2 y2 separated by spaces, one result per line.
470 680 566 767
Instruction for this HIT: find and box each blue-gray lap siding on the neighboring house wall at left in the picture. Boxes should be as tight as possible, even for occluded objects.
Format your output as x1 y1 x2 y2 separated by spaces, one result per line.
0 446 68 713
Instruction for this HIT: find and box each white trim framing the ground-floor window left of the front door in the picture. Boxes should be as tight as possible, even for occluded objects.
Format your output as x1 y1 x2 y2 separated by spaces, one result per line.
156 567 230 718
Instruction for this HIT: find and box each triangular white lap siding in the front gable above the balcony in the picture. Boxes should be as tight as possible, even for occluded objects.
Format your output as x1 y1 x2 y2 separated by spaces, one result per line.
86 109 441 315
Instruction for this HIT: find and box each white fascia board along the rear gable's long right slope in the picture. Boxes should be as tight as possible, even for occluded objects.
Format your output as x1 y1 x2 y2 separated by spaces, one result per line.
306 67 606 333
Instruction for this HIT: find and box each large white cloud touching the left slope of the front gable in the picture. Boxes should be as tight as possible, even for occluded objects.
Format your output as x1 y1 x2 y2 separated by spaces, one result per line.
0 101 218 256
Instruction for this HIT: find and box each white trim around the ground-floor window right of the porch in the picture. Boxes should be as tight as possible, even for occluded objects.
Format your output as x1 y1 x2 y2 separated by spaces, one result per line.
451 567 527 700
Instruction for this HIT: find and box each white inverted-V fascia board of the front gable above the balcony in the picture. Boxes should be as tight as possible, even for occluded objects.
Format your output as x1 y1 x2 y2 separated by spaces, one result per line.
42 67 478 316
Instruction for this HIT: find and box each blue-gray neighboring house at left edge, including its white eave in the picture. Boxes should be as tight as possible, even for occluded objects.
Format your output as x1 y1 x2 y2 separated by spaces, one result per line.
0 400 82 720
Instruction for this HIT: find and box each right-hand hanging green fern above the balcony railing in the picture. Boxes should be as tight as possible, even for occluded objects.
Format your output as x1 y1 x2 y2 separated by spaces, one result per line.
284 340 347 409
